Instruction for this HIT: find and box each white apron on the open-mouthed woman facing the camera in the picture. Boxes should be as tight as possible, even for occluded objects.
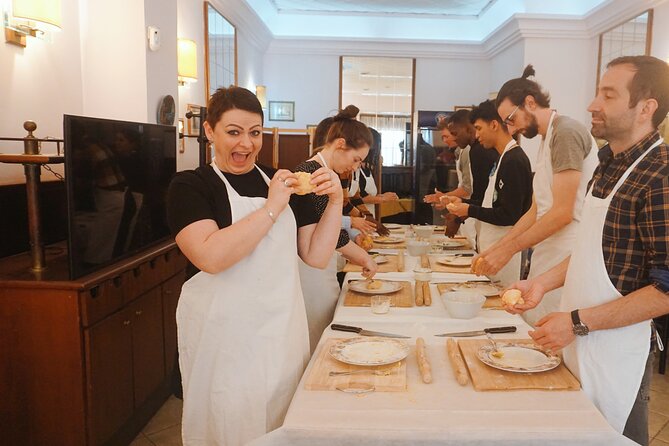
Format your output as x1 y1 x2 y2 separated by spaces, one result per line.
177 163 309 446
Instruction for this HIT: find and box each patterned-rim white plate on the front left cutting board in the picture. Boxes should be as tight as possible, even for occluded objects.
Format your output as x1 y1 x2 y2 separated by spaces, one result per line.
329 337 409 366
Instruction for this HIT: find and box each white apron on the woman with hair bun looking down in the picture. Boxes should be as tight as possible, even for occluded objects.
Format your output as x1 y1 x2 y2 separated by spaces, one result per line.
299 152 340 353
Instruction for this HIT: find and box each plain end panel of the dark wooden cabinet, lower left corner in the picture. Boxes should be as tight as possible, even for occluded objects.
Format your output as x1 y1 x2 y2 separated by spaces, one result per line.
0 284 86 446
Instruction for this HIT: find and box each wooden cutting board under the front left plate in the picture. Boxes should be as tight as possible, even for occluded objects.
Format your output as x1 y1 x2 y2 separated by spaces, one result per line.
304 339 411 392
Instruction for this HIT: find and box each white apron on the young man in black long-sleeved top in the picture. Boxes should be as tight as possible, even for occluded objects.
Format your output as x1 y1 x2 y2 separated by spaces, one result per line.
476 140 521 287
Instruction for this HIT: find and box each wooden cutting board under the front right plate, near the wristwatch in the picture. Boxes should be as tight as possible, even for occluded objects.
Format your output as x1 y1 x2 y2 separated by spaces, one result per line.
458 339 581 391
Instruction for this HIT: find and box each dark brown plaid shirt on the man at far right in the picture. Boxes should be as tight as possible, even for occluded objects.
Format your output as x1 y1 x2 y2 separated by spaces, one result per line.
588 132 669 295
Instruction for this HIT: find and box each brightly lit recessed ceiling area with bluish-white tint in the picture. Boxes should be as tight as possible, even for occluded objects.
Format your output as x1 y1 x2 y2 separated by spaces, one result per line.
240 0 612 43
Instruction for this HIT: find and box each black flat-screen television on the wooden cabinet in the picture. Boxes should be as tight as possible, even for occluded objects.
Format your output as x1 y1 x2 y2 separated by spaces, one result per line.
63 115 176 279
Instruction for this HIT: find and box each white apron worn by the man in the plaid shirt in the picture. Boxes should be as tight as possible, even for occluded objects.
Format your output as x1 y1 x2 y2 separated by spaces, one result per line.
560 139 662 433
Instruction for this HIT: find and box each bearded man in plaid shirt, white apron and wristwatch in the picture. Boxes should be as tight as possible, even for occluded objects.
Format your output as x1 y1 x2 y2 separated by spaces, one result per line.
510 56 669 445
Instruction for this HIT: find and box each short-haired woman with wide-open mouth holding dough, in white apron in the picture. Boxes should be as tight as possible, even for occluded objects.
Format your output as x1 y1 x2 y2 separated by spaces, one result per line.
167 87 343 446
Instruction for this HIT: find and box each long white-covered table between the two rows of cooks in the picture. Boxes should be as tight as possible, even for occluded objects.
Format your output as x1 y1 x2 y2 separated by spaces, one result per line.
253 232 635 446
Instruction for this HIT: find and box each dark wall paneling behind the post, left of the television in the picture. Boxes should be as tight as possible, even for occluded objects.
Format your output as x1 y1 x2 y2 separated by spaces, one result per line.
0 181 67 257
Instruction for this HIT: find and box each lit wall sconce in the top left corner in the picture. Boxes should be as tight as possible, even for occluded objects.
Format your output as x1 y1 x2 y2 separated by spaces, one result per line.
5 0 62 47
